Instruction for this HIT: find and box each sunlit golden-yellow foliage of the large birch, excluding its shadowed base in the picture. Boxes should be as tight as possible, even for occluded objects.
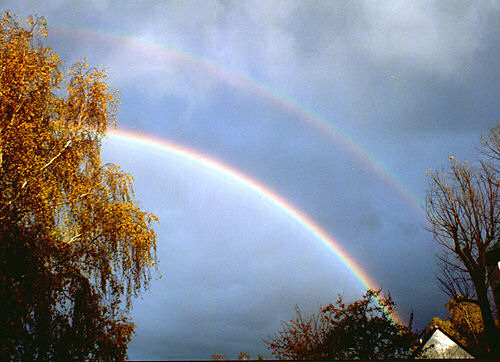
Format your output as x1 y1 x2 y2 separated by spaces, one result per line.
0 12 158 357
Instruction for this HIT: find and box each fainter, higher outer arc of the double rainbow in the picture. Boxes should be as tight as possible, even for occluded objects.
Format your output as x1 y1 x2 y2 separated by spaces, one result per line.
51 23 425 220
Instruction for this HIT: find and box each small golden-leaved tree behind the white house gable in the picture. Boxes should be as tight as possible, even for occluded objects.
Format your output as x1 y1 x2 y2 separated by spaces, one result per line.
429 298 488 356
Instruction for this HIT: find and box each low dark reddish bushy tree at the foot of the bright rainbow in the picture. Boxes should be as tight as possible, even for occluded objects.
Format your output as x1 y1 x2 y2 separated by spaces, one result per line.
266 290 415 360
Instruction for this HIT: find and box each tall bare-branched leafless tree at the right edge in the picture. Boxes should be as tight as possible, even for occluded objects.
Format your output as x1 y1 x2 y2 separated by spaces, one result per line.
426 131 500 356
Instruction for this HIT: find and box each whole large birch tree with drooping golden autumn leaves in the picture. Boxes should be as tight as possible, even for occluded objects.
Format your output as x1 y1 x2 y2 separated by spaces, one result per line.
0 12 157 360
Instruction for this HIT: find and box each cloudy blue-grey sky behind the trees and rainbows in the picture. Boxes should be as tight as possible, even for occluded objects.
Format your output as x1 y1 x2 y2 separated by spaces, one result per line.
0 0 500 360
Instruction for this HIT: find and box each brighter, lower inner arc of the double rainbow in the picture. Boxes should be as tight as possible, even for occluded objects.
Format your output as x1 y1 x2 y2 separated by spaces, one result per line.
108 130 402 323
